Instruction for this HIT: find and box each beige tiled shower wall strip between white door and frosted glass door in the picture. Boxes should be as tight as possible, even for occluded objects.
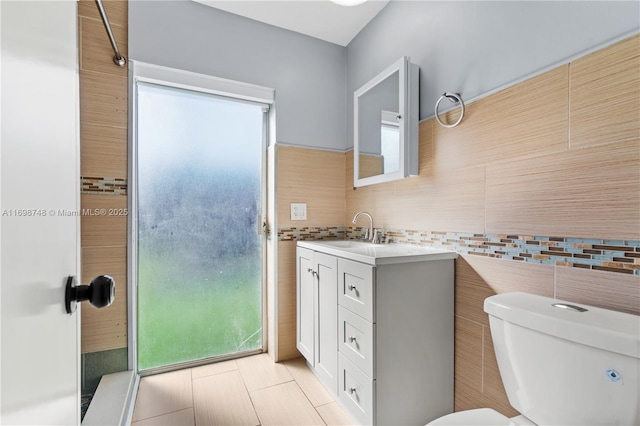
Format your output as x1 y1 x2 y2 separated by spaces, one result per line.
78 0 128 356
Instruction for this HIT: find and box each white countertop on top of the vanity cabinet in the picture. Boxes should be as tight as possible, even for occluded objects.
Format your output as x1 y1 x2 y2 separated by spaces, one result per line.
298 240 458 266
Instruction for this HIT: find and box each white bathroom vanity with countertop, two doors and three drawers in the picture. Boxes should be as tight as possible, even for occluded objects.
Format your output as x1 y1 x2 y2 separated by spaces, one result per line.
297 241 457 425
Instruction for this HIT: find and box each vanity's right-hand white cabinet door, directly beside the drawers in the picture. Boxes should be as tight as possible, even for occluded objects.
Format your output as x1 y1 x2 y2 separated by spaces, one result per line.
314 252 338 394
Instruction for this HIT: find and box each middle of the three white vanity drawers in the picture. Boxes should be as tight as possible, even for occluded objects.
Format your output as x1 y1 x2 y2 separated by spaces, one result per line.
338 306 376 379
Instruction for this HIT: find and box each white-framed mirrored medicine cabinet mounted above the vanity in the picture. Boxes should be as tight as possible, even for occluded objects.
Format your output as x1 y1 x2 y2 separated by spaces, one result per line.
353 57 419 187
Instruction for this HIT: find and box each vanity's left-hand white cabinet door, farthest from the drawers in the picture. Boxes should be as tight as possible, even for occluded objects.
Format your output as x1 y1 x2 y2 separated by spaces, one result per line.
296 247 316 365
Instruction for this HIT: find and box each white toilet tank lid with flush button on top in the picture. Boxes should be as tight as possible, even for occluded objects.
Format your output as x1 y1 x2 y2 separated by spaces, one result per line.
484 292 640 358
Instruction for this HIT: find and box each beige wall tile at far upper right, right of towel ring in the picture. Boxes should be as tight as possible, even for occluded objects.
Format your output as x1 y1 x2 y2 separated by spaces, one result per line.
570 35 640 149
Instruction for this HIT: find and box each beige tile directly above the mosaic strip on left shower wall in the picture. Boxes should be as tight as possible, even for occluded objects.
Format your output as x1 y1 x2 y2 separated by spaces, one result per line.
80 123 127 179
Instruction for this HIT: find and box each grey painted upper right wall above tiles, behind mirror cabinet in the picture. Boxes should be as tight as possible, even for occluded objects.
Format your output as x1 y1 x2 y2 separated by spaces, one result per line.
347 0 640 147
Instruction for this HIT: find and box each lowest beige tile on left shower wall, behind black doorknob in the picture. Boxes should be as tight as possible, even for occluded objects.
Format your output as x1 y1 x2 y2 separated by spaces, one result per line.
81 247 127 353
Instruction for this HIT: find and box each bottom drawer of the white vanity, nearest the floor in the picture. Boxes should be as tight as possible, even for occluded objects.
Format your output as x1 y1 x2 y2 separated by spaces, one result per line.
338 354 376 425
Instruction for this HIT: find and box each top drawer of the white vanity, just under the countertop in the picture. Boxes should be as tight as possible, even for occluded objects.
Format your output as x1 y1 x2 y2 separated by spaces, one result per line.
338 258 375 322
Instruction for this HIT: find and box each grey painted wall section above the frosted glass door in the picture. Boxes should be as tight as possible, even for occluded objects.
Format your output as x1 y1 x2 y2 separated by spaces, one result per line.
129 0 347 150
